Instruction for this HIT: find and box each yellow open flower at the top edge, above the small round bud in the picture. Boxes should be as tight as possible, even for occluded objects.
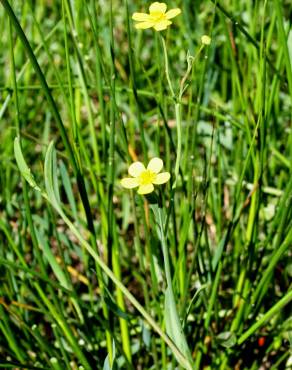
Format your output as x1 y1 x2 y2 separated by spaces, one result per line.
132 2 181 31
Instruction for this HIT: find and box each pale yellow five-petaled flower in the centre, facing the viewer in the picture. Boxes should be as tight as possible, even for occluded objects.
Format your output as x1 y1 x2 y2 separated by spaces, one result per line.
121 158 170 194
